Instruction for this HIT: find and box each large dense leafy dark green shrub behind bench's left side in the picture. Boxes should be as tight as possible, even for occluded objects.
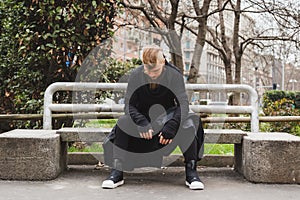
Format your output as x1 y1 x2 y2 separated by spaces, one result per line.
0 0 120 129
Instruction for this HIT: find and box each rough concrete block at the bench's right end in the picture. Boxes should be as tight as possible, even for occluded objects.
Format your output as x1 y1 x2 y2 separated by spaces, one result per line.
243 133 300 184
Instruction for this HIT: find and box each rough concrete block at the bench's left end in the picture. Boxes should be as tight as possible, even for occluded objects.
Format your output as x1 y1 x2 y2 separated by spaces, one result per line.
0 129 66 180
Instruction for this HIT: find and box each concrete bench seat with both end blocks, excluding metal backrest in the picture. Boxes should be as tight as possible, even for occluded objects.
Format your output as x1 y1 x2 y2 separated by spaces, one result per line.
0 128 300 184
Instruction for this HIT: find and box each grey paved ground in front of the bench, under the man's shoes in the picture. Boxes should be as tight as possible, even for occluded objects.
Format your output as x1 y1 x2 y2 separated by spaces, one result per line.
0 166 300 200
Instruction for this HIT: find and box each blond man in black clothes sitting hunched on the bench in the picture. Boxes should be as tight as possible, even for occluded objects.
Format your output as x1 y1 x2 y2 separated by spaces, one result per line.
102 46 204 189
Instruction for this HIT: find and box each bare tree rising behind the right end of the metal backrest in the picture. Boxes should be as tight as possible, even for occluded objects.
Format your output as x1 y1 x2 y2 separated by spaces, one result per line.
203 0 300 104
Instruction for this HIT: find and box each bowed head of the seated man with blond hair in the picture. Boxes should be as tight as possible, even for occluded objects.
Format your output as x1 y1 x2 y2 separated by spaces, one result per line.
142 45 165 68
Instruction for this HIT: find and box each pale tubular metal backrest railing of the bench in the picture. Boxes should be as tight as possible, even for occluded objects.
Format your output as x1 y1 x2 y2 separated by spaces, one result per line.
43 82 259 132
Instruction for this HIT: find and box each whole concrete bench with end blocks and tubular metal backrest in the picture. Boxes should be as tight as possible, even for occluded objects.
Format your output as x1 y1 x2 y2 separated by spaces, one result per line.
0 82 300 183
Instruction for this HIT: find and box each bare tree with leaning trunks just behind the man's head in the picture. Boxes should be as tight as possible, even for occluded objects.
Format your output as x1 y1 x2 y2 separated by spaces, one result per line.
119 0 216 76
